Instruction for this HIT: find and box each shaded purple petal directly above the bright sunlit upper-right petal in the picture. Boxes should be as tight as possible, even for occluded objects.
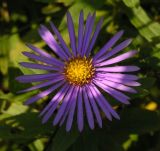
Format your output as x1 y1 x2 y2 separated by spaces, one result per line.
94 39 132 63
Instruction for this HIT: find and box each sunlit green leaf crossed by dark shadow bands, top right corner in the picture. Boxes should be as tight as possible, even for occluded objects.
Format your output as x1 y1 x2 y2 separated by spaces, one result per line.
123 0 160 48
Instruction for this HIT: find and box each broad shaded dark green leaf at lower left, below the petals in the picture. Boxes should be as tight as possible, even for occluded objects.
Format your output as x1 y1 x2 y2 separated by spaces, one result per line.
0 111 54 143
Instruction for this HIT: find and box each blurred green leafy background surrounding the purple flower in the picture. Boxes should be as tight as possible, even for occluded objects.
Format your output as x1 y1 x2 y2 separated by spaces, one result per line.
0 0 160 151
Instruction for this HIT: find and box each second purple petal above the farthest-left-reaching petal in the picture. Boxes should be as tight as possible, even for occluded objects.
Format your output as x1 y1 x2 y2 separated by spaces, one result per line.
22 52 64 67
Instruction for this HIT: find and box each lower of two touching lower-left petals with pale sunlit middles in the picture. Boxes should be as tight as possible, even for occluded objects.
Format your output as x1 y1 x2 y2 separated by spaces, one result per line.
42 84 69 123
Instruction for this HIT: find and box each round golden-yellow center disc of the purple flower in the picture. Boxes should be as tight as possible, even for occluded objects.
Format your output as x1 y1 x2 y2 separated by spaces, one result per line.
64 57 95 86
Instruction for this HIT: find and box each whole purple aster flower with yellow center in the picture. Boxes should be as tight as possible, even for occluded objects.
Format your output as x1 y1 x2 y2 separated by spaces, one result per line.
16 11 140 131
